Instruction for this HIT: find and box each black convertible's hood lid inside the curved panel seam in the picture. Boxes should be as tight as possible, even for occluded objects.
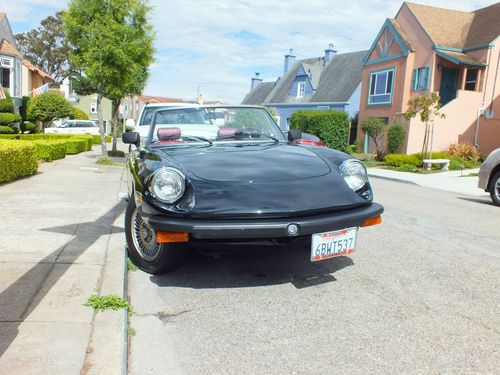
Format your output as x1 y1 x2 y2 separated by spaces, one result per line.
158 143 330 183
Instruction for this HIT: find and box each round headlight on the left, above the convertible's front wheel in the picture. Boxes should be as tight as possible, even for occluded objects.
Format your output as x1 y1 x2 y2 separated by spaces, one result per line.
149 167 186 204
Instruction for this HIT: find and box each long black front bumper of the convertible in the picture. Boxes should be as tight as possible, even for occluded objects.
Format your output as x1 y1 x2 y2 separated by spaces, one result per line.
146 203 384 239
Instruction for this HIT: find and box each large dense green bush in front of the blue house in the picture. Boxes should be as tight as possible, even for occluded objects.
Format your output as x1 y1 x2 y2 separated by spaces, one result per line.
290 110 350 152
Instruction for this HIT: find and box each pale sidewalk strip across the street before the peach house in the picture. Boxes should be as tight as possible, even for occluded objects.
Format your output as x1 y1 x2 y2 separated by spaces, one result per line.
367 168 488 197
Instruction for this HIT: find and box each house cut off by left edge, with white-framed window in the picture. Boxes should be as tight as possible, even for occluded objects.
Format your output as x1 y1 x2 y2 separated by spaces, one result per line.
0 12 22 108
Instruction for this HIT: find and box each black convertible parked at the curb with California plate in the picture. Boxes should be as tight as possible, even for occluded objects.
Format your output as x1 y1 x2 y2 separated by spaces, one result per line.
123 106 383 274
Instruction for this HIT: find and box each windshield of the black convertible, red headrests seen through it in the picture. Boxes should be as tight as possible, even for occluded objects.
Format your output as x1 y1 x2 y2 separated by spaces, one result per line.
148 107 285 146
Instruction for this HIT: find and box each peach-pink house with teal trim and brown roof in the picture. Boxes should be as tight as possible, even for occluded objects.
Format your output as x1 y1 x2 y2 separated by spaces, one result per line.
358 2 500 154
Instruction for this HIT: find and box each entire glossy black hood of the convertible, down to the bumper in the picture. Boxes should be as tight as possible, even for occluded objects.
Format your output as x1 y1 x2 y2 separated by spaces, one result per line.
146 144 369 219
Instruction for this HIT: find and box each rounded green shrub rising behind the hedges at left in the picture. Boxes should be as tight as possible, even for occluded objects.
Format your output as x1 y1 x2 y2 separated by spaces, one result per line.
28 92 74 129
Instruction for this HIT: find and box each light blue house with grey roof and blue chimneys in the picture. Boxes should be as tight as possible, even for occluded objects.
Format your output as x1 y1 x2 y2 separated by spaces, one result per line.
242 44 366 130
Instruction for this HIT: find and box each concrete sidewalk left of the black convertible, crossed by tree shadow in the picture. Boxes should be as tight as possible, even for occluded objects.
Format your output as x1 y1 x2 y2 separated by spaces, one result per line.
0 147 127 375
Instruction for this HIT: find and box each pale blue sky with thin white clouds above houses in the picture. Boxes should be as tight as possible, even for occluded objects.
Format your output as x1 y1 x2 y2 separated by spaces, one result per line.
0 0 495 104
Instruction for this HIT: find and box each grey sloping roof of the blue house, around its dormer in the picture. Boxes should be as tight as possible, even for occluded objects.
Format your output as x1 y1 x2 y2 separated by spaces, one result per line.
242 51 367 104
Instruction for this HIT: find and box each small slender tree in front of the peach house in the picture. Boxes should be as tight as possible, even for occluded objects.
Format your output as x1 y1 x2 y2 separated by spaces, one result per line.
404 92 446 159
